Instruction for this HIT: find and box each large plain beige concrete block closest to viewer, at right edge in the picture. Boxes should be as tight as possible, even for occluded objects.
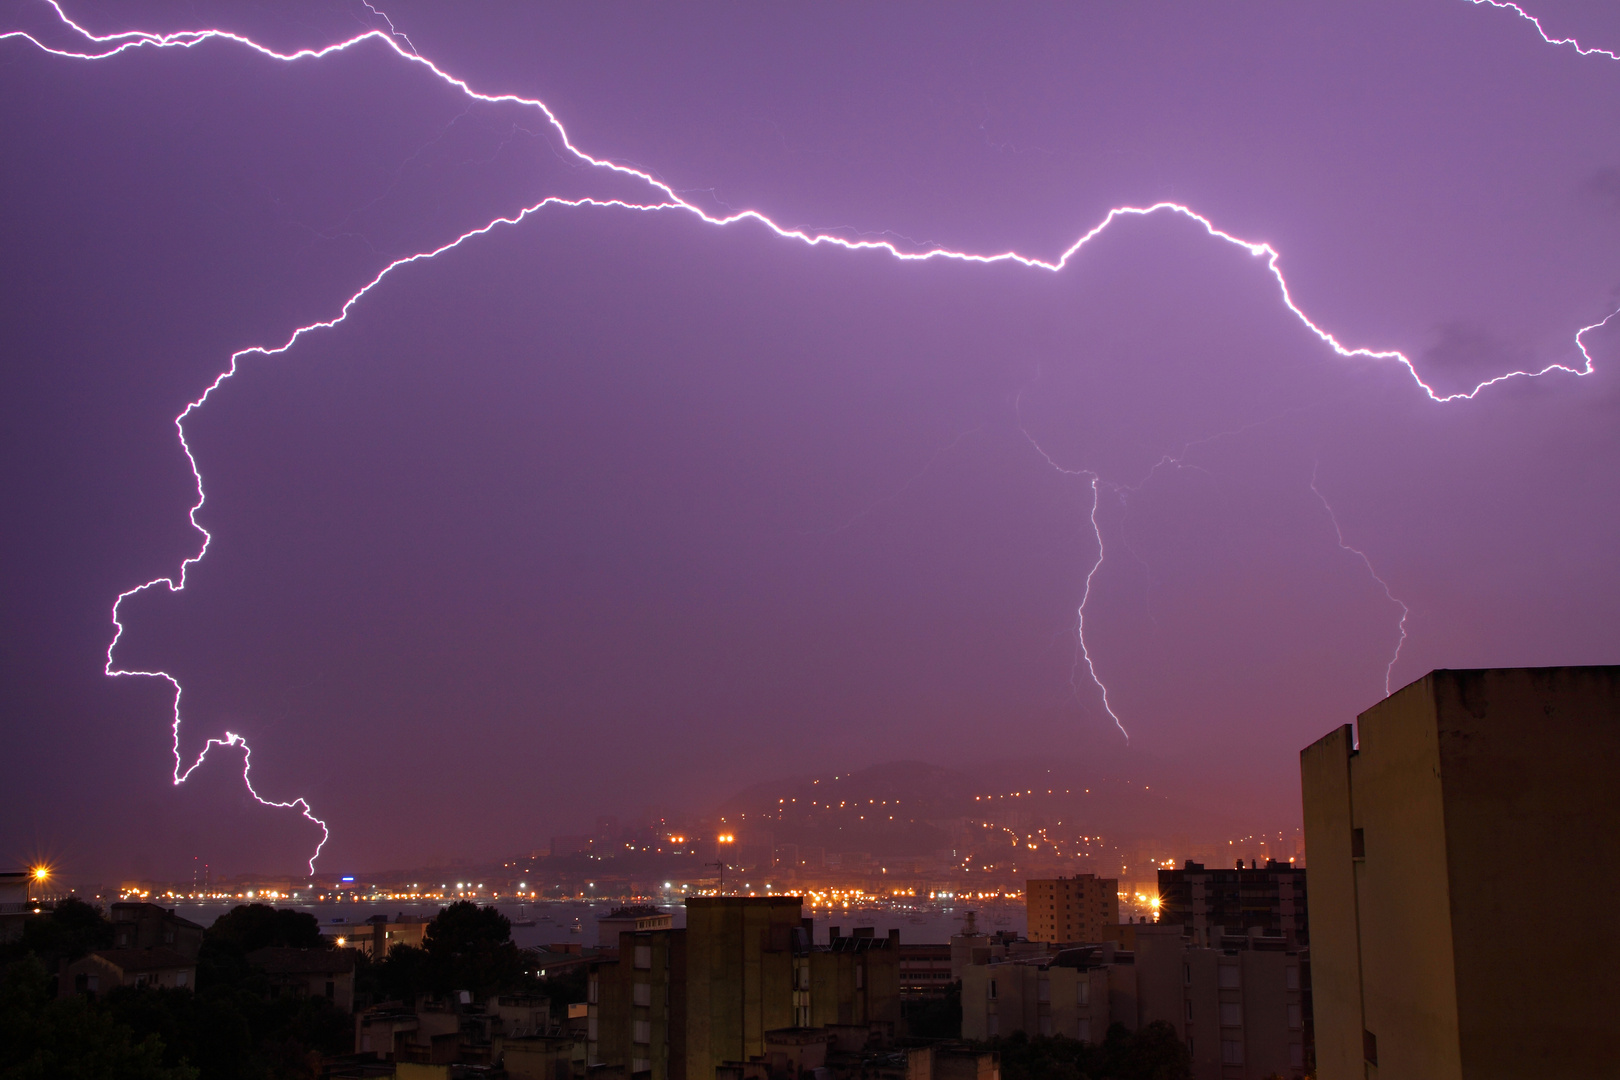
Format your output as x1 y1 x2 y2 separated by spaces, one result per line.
1299 667 1620 1080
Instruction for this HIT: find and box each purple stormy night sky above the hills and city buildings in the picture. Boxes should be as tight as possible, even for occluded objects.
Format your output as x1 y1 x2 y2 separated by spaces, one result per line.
0 0 1620 876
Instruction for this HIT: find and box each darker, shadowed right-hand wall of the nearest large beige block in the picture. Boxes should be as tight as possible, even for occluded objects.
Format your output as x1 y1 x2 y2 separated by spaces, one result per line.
1430 667 1620 1078
